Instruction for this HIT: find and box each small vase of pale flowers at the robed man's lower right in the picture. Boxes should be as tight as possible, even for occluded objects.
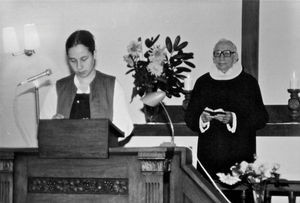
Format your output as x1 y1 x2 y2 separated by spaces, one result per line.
217 160 280 202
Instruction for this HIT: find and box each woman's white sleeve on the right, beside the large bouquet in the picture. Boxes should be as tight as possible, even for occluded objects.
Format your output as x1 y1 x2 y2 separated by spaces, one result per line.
112 80 133 137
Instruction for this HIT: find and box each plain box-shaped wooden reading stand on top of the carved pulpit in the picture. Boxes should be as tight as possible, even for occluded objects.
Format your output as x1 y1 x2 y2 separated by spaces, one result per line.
38 119 124 158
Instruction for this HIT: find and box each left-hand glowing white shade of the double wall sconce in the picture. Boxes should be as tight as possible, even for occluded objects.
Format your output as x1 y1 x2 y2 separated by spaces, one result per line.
2 27 20 53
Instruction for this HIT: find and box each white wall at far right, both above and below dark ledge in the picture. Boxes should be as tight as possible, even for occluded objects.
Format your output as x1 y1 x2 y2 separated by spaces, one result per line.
257 0 300 180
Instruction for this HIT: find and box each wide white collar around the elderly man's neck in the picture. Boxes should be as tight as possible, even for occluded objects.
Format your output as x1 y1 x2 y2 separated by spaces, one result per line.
209 62 243 80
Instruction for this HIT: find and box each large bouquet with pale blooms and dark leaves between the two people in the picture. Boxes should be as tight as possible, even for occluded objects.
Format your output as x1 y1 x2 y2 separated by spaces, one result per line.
124 35 195 101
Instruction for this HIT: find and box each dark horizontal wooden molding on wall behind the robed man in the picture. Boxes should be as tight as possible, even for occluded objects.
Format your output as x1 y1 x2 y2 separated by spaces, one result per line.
134 105 300 136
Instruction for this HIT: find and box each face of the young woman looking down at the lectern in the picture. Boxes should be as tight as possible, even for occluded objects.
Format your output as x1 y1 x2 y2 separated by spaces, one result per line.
68 44 95 78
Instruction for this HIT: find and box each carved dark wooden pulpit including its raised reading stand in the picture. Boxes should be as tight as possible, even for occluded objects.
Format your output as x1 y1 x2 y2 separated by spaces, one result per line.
0 120 226 203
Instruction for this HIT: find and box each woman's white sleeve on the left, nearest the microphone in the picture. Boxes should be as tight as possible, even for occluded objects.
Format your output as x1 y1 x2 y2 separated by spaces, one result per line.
40 84 57 119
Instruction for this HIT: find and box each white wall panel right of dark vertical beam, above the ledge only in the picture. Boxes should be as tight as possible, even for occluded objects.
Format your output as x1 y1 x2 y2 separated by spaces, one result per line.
259 0 300 104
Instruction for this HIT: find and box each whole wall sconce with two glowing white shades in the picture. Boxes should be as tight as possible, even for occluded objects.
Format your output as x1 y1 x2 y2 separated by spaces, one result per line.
2 24 40 56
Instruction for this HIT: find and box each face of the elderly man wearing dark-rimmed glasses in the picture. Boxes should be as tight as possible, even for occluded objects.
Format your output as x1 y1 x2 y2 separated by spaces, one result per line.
213 43 237 73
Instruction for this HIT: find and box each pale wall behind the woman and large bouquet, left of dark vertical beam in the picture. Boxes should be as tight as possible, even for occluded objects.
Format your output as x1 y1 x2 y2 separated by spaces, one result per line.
0 0 241 147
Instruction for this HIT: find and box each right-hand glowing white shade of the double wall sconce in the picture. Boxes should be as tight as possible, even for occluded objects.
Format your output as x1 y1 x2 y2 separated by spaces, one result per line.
24 24 40 50
